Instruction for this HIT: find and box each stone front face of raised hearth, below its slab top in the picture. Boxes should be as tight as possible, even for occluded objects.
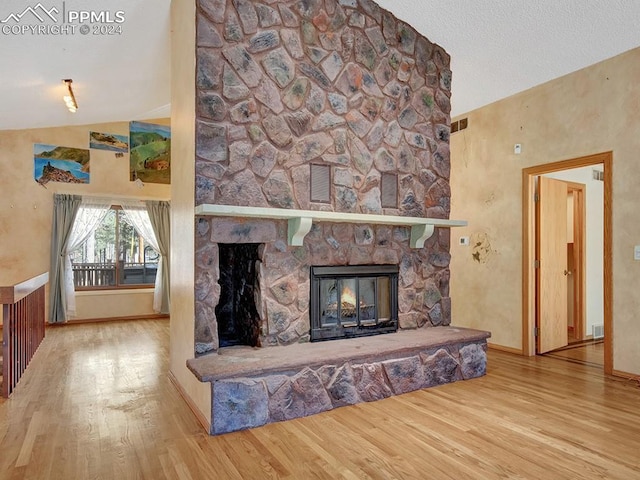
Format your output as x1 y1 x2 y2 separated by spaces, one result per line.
210 342 486 435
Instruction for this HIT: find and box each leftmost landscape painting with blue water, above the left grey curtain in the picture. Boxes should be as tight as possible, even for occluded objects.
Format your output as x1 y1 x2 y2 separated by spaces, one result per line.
33 143 90 185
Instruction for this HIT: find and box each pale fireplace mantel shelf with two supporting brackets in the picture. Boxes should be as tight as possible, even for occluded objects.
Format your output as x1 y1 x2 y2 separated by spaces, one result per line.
195 203 467 248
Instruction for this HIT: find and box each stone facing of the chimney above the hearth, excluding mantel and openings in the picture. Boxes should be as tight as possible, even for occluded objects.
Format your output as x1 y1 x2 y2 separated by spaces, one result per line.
195 0 451 352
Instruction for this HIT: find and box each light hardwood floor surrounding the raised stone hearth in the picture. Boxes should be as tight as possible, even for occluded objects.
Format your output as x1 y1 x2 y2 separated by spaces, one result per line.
0 320 640 480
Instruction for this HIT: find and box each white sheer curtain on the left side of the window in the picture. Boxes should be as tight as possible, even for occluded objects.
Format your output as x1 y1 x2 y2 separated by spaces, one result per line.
63 198 111 319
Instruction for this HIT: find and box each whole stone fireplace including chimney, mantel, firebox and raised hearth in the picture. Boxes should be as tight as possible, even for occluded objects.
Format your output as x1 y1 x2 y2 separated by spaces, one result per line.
189 0 487 433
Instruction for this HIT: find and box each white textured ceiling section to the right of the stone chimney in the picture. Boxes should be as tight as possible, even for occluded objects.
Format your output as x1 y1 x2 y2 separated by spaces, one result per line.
378 0 640 116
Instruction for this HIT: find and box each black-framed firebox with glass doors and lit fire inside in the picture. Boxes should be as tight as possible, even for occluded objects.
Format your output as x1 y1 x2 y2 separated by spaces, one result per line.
310 265 398 342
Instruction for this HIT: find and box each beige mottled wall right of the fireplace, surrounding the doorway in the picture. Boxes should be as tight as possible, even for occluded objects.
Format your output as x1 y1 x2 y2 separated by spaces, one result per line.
451 48 640 374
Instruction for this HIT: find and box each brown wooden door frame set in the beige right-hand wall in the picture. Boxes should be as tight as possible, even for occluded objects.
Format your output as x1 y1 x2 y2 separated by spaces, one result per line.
522 152 613 374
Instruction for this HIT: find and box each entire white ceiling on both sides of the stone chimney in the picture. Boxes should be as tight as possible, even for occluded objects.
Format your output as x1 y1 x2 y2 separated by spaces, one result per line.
0 0 640 130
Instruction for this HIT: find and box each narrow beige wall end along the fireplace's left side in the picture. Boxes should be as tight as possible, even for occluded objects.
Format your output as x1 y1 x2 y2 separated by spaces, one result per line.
169 0 211 430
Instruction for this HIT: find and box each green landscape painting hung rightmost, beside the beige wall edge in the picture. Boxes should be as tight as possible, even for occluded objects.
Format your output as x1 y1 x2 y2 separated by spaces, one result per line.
129 122 171 184
